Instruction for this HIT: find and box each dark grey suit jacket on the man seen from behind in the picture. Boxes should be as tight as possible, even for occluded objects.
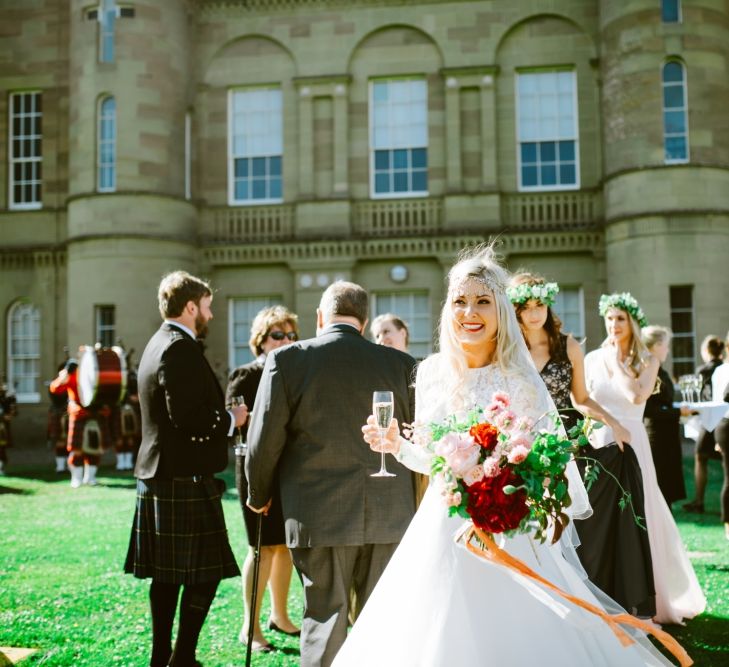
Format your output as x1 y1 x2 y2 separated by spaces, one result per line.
246 324 415 547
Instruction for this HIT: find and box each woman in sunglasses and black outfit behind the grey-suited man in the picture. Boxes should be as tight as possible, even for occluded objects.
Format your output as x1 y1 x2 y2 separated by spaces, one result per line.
225 306 299 652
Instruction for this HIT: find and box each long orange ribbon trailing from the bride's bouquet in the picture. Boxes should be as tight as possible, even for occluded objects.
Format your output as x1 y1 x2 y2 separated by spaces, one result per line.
464 526 694 667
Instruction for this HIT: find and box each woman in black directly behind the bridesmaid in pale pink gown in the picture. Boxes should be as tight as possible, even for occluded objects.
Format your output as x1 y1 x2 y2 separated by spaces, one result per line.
642 326 690 508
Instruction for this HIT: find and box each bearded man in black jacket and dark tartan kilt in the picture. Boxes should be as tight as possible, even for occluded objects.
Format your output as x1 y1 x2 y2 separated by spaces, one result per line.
124 271 248 667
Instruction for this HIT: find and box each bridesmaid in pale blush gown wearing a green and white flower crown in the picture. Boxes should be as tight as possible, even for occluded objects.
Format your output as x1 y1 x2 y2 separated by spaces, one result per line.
585 292 706 624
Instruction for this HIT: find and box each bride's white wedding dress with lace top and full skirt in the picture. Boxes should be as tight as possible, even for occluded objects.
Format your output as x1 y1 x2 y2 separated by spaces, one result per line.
334 355 671 667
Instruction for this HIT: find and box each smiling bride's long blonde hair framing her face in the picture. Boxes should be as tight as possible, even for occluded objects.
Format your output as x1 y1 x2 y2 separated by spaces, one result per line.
439 243 533 408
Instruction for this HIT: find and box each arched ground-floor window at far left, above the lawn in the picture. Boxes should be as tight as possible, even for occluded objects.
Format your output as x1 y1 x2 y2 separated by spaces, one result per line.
8 301 40 403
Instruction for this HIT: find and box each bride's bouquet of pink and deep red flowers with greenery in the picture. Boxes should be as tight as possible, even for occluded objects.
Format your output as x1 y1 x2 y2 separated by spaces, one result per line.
410 392 587 542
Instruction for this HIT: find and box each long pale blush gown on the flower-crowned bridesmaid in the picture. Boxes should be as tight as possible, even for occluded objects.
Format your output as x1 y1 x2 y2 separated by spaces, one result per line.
585 349 706 623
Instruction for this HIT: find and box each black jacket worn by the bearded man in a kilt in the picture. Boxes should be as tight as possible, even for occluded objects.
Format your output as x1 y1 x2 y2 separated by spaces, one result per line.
134 322 231 479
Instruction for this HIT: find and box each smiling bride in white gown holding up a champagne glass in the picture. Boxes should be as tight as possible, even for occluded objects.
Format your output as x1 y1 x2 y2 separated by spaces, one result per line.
334 247 671 667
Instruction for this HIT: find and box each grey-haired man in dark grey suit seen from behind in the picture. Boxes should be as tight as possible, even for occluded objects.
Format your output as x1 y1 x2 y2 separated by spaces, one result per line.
246 282 415 667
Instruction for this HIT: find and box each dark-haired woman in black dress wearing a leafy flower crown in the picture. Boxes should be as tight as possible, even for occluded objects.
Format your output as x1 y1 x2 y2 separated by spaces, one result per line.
509 272 655 618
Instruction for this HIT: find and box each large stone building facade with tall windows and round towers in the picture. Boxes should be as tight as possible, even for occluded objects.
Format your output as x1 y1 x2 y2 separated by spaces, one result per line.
0 0 729 444
